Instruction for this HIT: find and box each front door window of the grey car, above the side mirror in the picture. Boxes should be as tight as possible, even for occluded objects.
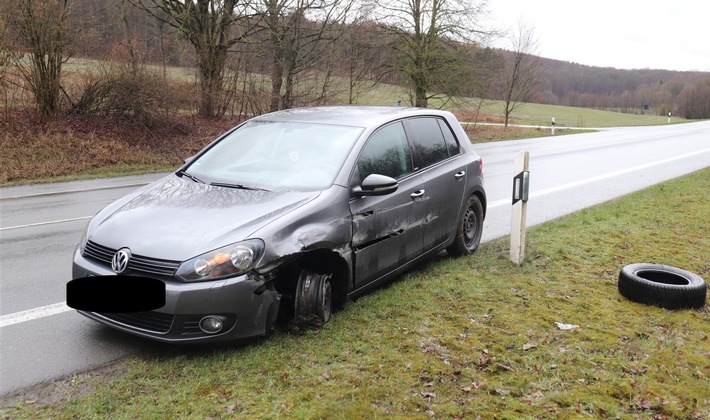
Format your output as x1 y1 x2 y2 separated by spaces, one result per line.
357 122 412 180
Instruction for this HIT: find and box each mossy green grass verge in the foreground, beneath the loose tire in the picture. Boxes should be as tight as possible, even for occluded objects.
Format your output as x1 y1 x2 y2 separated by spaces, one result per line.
0 169 710 419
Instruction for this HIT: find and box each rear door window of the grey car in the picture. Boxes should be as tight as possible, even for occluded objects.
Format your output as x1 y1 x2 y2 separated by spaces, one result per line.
407 118 458 170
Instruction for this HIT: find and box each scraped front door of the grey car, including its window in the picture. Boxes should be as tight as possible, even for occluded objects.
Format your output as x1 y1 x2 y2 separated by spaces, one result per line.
350 122 424 289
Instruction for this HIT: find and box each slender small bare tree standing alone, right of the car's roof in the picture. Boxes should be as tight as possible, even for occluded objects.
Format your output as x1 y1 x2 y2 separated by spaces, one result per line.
503 22 540 127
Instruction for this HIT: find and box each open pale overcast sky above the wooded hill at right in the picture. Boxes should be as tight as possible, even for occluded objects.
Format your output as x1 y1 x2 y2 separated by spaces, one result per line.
487 0 710 71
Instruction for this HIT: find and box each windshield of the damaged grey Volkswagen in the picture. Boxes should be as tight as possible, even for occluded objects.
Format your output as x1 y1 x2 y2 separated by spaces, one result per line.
187 121 363 191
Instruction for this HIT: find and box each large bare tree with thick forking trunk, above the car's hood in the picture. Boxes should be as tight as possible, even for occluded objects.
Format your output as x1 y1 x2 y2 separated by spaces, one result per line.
131 0 253 117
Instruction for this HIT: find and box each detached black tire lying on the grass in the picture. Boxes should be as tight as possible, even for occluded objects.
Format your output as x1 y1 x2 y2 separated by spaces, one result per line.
619 263 707 309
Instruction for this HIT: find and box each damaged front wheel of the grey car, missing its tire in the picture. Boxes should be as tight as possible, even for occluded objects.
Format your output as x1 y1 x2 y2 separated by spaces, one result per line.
294 270 333 323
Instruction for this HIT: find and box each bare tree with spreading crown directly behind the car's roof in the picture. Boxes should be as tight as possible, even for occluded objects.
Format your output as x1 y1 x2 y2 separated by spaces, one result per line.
377 0 487 107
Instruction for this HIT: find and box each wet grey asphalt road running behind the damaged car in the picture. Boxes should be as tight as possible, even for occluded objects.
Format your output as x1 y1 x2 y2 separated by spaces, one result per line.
0 121 710 395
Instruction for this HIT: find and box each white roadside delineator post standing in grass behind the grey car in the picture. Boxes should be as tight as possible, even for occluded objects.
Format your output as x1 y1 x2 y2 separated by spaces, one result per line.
510 151 530 265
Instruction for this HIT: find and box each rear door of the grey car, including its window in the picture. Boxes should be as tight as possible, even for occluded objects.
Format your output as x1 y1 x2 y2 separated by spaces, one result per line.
406 117 466 252
